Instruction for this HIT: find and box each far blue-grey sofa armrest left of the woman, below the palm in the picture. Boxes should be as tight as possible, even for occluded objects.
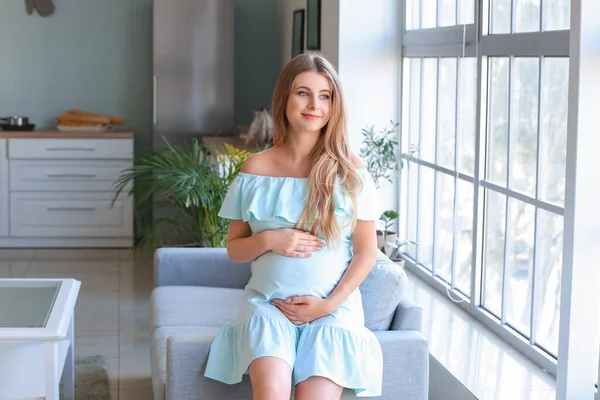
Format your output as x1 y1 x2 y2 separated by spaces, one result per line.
154 248 250 289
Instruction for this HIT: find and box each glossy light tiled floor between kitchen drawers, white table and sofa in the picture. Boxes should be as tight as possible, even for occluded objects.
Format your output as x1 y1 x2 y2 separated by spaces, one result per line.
0 249 153 400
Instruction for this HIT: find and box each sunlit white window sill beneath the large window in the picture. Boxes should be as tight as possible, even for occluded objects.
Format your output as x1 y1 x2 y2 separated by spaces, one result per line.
406 269 556 400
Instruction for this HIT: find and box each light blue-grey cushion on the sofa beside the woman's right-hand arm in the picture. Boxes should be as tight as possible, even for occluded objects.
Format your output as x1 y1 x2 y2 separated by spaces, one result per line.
360 252 407 331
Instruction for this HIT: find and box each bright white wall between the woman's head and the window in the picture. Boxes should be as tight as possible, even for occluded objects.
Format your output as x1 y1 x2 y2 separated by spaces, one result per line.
338 0 400 209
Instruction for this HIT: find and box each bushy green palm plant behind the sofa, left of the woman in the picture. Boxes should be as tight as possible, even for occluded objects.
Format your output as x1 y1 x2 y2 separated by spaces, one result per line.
113 139 251 251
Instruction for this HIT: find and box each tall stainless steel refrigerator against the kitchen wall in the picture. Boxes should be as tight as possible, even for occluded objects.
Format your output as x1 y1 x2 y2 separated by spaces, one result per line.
152 0 235 148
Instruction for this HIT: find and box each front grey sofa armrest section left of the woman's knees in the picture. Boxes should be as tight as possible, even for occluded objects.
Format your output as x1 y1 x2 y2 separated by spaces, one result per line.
166 334 252 400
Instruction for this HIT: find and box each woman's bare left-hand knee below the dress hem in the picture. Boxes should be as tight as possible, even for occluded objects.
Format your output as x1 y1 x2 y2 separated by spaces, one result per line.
248 357 292 400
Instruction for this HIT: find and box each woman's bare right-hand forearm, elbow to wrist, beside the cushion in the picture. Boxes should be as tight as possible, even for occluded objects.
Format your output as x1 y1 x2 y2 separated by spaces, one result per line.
325 220 377 312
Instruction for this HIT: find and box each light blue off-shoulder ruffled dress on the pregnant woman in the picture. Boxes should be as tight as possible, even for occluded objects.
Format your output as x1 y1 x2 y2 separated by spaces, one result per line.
205 168 383 397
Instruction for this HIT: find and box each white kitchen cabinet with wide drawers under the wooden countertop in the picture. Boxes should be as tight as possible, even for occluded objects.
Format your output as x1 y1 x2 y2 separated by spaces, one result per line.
0 132 133 247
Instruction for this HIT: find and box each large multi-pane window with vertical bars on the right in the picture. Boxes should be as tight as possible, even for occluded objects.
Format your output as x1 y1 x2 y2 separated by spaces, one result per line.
400 0 570 373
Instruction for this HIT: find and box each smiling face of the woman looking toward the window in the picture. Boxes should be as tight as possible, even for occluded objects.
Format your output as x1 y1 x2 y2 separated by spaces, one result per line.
285 71 331 132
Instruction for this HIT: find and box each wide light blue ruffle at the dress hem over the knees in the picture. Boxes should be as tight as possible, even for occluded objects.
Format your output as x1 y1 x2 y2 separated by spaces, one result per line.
205 316 383 397
